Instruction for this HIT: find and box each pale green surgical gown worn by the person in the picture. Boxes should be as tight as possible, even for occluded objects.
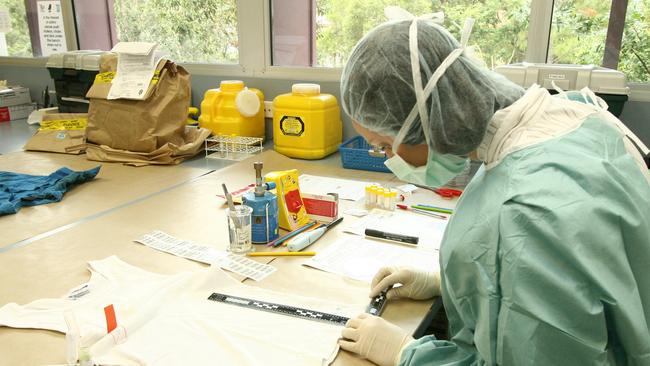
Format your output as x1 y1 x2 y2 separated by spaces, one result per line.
400 114 650 366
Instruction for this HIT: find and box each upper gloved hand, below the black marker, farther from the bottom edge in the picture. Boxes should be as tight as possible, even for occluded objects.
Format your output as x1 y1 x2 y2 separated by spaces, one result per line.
370 266 440 300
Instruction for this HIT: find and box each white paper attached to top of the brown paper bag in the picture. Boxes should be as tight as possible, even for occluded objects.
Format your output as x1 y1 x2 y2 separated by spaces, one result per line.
107 42 156 100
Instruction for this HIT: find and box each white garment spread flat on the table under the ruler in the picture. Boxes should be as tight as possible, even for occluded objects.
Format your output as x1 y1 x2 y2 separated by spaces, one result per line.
0 257 365 366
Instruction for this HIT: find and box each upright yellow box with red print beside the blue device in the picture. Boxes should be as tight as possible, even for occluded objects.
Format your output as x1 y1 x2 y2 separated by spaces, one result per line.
264 169 309 231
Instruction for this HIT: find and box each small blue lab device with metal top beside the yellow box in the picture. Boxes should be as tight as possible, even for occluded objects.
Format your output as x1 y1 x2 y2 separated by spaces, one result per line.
242 162 278 244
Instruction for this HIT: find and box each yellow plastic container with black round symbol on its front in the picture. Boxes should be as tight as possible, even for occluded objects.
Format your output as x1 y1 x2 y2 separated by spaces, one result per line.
273 84 343 159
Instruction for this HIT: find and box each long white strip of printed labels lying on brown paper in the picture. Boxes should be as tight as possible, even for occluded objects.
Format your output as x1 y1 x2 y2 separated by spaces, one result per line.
135 230 276 281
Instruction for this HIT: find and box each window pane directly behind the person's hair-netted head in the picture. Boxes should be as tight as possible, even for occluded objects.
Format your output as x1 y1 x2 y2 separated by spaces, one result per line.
272 0 530 68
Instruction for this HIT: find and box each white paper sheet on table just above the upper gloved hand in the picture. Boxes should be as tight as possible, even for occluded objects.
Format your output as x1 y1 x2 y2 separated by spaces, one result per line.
303 237 439 283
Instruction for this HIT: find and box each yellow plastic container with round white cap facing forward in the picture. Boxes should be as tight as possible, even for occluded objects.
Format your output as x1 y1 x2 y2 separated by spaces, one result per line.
199 80 264 138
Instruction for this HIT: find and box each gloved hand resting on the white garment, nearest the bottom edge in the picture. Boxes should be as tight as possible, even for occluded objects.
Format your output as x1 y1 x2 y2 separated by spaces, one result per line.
339 313 414 366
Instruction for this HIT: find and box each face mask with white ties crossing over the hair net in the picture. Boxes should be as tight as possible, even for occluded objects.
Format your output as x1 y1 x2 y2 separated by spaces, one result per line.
384 11 474 187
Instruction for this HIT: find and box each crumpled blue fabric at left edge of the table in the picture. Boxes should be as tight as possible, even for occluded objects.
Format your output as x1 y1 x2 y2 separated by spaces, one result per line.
0 166 100 215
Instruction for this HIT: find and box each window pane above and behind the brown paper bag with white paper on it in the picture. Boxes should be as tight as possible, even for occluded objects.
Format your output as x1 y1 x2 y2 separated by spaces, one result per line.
74 0 239 63
